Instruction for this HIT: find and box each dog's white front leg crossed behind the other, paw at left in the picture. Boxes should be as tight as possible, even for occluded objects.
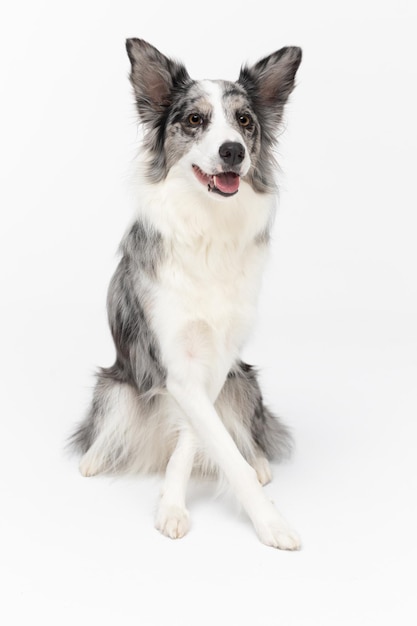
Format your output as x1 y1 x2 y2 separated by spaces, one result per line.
155 427 196 539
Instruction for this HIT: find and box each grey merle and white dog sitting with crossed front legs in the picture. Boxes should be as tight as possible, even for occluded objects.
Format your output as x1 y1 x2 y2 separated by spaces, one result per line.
71 39 301 550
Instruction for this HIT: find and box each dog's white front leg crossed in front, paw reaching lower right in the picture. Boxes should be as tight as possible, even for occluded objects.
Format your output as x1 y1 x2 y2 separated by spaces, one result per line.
167 372 300 550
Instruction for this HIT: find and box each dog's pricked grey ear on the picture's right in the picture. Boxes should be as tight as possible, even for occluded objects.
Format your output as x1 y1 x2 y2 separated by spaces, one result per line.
238 46 302 110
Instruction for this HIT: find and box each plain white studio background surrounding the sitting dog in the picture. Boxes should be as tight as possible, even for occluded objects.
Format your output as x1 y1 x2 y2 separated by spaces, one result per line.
0 0 417 626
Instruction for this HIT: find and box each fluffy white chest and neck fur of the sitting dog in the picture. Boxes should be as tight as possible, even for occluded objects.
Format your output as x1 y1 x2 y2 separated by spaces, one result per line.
138 181 275 390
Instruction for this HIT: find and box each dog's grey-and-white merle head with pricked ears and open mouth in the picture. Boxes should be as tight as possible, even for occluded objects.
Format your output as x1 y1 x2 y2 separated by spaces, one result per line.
126 39 301 197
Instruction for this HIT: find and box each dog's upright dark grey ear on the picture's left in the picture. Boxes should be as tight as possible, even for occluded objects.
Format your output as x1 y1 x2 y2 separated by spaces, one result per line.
126 39 191 122
